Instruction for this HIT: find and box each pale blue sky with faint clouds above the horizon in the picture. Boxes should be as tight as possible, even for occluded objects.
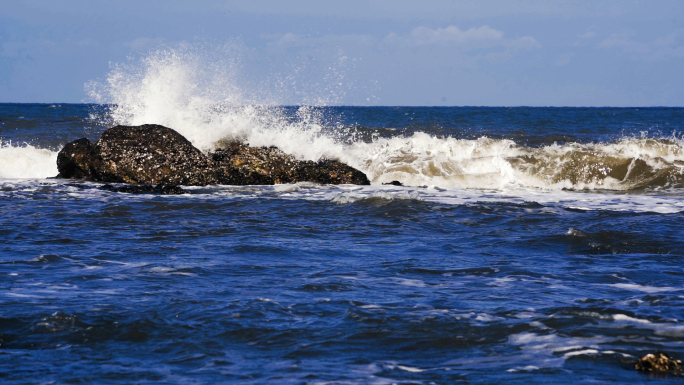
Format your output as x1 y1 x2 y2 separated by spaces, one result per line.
0 0 684 107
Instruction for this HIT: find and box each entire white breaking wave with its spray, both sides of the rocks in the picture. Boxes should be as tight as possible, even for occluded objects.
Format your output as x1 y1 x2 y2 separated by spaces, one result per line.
0 45 684 191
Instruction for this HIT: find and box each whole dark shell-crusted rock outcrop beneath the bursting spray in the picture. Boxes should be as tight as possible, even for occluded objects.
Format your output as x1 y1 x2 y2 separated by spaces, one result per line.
57 124 370 186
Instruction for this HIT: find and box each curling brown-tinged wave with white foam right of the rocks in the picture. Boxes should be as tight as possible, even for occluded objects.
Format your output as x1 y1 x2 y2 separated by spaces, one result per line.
349 133 684 190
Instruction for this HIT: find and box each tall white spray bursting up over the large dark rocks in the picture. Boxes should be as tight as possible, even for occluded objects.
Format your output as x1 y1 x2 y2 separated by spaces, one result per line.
89 45 350 160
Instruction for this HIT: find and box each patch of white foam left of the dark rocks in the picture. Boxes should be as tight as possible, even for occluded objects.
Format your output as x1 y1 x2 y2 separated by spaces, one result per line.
0 143 58 178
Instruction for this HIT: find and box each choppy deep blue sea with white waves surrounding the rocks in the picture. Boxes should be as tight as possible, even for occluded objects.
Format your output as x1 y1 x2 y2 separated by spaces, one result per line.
0 100 684 384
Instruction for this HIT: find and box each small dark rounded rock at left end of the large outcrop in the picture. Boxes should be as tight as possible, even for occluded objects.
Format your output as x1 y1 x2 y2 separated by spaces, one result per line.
57 138 102 179
